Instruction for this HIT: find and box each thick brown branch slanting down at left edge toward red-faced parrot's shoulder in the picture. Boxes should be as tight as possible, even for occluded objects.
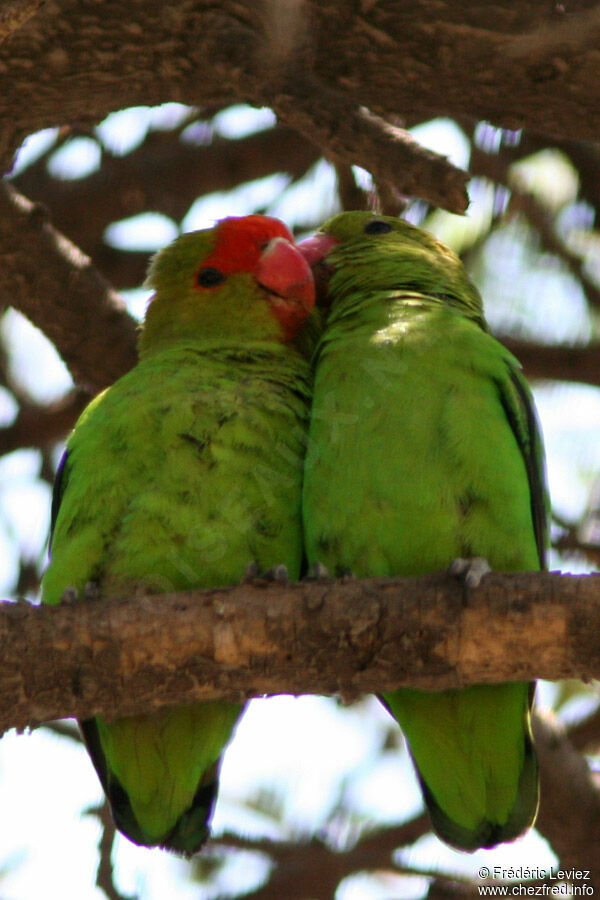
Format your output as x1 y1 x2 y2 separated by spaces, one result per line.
0 185 137 393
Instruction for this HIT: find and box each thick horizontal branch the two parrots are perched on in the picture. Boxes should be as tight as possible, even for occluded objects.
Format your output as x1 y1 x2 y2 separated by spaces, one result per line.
0 573 600 728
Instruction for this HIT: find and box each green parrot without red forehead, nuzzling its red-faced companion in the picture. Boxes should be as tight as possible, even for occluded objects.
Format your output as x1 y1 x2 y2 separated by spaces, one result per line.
299 212 547 851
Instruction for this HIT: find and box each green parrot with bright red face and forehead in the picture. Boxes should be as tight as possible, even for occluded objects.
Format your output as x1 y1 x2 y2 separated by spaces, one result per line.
42 215 314 854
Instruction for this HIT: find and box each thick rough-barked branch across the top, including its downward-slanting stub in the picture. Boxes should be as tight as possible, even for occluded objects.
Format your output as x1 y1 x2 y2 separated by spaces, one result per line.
0 0 600 211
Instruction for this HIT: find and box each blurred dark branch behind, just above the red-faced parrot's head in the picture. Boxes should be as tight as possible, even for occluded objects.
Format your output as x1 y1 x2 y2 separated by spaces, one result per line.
12 122 319 288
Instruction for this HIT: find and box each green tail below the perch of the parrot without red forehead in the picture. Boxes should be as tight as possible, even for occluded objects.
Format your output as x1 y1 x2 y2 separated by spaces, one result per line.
380 683 539 851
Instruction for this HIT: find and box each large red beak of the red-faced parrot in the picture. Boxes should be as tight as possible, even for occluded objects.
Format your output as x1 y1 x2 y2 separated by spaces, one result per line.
256 237 315 340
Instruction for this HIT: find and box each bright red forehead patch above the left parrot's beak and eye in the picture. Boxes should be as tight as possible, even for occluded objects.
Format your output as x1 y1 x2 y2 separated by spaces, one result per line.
202 215 294 275
